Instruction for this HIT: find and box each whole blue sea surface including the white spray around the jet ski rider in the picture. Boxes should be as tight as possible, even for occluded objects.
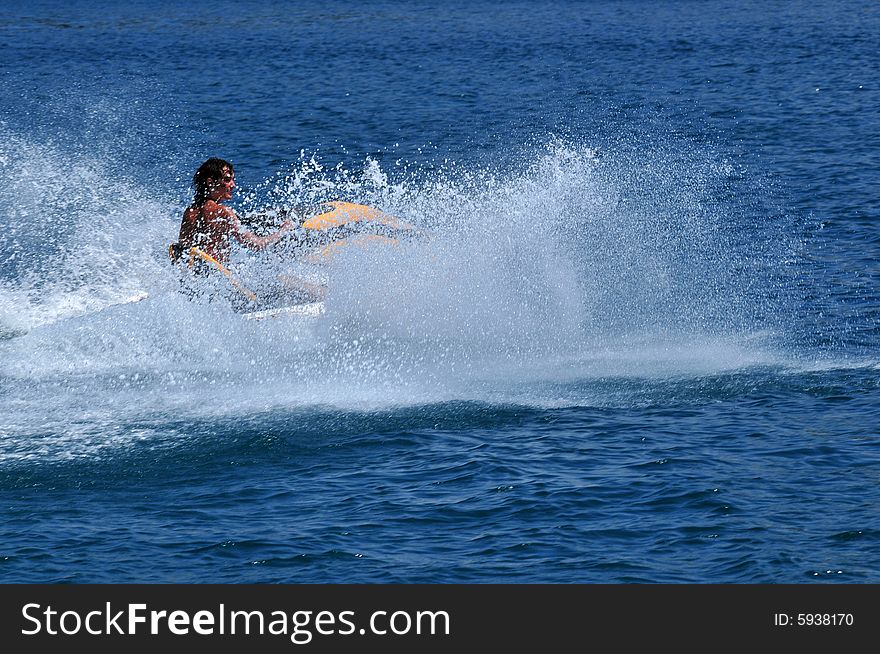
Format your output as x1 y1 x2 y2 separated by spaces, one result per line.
0 0 880 583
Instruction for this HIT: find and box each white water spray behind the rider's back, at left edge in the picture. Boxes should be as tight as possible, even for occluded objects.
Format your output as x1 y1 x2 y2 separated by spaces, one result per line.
0 129 179 333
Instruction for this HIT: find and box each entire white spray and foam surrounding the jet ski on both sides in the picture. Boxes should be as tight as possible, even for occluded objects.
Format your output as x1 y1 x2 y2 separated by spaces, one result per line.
0 129 800 426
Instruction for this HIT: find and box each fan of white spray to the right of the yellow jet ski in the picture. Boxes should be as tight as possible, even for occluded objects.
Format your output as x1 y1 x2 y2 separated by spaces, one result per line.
310 142 789 380
